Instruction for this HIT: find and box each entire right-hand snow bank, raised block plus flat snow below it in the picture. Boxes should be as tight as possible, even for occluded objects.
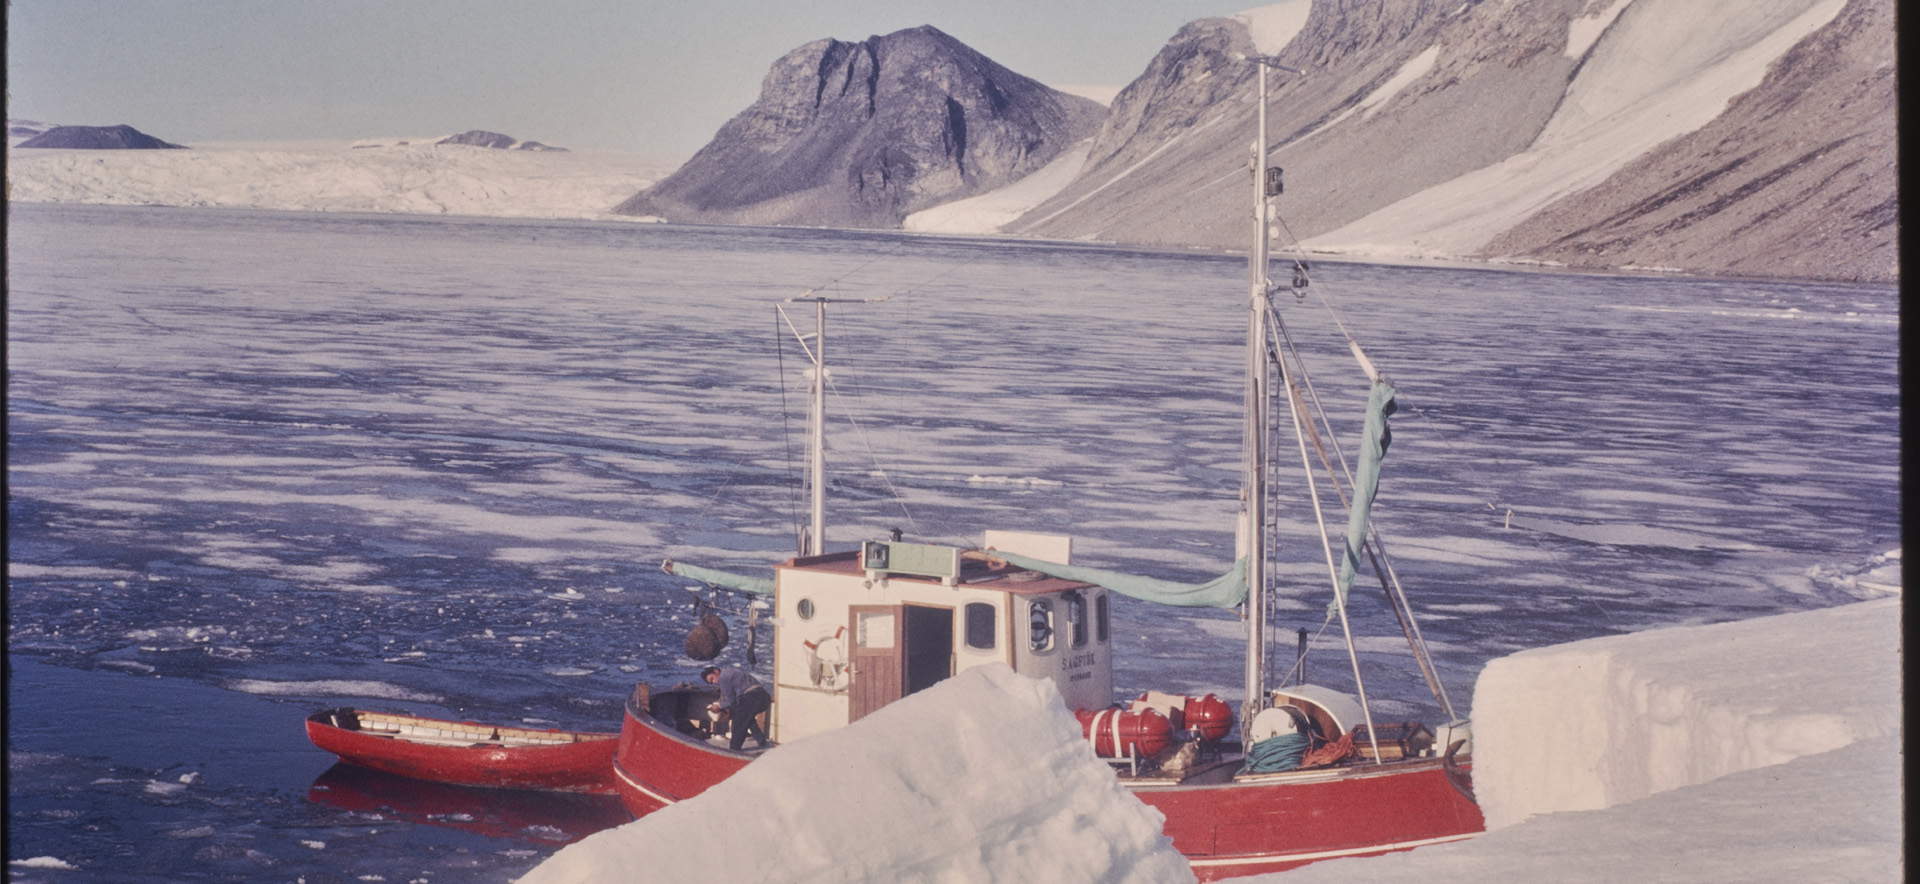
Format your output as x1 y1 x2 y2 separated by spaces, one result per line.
1248 598 1905 884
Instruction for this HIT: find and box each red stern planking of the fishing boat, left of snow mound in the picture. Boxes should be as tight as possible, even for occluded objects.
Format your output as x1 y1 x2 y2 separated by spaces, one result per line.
612 692 753 817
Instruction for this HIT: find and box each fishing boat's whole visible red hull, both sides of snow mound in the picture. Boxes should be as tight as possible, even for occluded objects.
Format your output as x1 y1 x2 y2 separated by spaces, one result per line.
614 698 1486 880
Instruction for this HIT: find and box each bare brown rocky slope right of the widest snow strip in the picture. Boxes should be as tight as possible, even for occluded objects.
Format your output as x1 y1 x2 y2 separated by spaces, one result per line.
1482 2 1899 279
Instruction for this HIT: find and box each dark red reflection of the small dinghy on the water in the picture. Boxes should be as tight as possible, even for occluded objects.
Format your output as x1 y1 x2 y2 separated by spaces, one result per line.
307 763 634 844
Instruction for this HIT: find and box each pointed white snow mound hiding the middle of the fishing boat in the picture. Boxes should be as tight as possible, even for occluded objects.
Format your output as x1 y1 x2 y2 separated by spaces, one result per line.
520 667 1194 884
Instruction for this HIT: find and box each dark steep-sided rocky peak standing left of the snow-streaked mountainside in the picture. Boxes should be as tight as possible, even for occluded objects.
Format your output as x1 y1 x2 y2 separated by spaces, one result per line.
614 27 1106 229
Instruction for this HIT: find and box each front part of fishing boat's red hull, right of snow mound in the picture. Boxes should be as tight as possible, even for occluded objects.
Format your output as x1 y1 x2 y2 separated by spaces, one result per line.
1127 759 1486 880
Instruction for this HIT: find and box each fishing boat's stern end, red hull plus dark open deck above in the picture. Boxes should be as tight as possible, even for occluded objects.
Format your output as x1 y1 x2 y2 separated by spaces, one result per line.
612 684 755 817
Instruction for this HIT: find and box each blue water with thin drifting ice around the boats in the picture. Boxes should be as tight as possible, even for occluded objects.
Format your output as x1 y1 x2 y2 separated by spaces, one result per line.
8 206 1901 882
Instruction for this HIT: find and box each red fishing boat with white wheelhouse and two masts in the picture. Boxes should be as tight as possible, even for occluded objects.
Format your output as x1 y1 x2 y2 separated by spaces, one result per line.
614 58 1484 880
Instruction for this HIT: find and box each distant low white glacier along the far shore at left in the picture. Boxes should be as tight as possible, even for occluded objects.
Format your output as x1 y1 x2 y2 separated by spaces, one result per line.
6 138 672 217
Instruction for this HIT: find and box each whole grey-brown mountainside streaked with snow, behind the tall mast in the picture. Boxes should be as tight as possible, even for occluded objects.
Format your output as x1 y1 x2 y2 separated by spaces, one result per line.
1006 0 1899 281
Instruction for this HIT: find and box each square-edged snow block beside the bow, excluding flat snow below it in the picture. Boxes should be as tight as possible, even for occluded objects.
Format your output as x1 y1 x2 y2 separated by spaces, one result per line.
1473 600 1901 830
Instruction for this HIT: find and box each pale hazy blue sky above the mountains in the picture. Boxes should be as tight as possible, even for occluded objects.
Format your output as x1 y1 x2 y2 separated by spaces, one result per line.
6 0 1261 158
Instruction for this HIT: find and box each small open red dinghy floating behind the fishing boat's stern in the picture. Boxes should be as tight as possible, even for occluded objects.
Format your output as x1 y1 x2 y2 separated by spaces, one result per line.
307 709 618 796
